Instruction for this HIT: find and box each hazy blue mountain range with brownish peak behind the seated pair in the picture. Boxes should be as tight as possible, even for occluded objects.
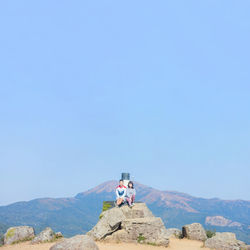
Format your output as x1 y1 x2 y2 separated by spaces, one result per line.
0 181 250 244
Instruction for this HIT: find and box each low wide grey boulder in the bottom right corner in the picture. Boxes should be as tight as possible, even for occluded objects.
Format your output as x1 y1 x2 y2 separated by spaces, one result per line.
205 232 247 250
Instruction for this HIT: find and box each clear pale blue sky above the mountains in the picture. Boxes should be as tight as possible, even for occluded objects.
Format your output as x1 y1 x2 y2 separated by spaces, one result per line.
0 0 250 205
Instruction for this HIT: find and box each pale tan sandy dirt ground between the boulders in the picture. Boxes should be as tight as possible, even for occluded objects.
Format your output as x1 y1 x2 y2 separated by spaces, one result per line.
0 239 208 250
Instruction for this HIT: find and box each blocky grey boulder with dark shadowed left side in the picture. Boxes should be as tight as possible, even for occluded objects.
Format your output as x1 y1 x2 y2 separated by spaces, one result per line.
182 223 207 241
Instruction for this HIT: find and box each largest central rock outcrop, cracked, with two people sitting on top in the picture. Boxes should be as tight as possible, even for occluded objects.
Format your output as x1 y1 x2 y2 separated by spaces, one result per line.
88 203 169 246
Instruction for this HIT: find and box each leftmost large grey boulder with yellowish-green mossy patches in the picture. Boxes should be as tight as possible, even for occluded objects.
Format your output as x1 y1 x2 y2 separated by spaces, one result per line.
4 226 35 245
